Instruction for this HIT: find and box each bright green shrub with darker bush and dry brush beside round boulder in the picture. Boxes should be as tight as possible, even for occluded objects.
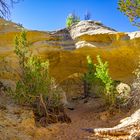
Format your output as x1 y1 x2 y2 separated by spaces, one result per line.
83 55 130 107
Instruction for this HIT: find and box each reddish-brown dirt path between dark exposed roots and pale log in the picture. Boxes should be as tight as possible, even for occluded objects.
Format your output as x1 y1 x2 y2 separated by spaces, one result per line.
50 99 129 140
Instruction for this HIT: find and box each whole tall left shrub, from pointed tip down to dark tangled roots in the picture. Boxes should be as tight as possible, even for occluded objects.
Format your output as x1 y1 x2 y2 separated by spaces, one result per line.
12 31 70 126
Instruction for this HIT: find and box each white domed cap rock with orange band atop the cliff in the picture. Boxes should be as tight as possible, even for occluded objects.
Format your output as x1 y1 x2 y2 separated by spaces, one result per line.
70 20 129 48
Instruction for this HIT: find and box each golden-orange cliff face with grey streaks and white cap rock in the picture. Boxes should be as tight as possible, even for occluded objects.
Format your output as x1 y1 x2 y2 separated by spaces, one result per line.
0 19 140 91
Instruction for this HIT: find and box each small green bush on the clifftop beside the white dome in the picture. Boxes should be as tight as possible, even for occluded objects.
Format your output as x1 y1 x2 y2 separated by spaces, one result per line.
66 13 80 27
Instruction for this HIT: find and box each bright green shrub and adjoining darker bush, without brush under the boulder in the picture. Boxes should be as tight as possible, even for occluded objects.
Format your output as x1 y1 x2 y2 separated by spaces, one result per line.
84 56 116 105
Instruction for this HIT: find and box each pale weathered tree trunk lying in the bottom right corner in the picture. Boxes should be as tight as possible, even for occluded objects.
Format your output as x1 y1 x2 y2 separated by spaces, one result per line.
84 109 140 140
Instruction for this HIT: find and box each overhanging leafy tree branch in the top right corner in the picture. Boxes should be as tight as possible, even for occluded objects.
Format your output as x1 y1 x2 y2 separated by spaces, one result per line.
118 0 140 27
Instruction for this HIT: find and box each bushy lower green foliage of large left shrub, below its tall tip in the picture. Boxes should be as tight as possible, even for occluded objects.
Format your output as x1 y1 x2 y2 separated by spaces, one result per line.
15 56 51 103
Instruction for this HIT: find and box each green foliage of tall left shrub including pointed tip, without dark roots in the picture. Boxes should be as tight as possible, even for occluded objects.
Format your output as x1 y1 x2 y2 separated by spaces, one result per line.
15 31 59 104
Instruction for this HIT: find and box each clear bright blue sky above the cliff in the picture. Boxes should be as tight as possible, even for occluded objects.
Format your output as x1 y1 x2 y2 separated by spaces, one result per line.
11 0 138 32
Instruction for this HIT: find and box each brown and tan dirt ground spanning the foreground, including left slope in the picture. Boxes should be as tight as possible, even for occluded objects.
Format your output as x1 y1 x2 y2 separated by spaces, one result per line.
0 91 129 140
